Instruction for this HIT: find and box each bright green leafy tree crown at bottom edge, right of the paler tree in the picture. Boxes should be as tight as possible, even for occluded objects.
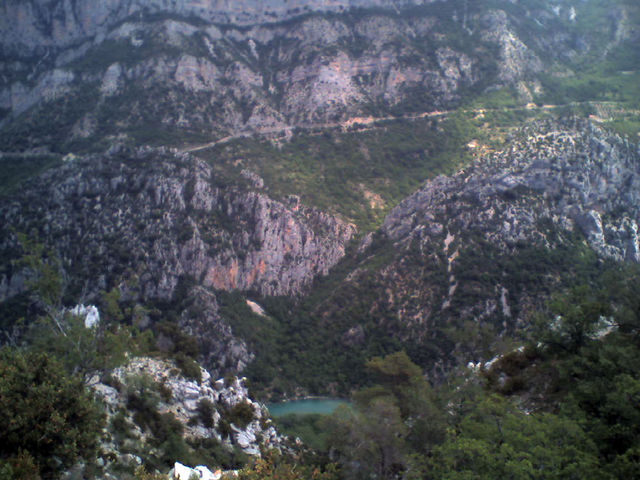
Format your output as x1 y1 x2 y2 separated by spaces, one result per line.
430 396 610 480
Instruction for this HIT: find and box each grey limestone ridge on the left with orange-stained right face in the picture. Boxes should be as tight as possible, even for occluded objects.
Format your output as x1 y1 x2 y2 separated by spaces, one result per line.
2 150 355 299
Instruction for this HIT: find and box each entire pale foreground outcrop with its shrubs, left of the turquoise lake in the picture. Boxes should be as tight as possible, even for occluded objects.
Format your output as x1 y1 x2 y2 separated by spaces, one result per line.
91 357 286 472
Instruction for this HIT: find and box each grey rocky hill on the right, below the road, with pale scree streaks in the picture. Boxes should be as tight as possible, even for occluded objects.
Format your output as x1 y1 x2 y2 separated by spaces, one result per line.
319 119 640 376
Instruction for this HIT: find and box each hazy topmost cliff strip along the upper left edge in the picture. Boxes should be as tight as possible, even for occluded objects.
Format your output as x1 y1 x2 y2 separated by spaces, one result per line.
0 0 440 54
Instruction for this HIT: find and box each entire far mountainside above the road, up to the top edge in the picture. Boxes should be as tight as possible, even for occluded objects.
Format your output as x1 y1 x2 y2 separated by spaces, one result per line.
0 1 637 152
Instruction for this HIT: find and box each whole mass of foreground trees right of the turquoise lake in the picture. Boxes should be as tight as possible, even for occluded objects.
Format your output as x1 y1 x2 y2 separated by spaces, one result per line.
312 272 640 480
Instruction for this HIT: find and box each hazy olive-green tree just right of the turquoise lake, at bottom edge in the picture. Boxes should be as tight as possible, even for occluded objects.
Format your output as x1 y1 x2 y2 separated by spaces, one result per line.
328 352 446 479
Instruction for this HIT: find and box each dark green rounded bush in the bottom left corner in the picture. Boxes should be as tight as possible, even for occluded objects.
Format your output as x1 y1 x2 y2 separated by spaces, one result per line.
0 348 103 478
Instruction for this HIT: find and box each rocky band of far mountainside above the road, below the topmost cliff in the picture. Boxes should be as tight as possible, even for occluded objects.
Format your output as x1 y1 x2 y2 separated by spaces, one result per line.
0 6 500 151
